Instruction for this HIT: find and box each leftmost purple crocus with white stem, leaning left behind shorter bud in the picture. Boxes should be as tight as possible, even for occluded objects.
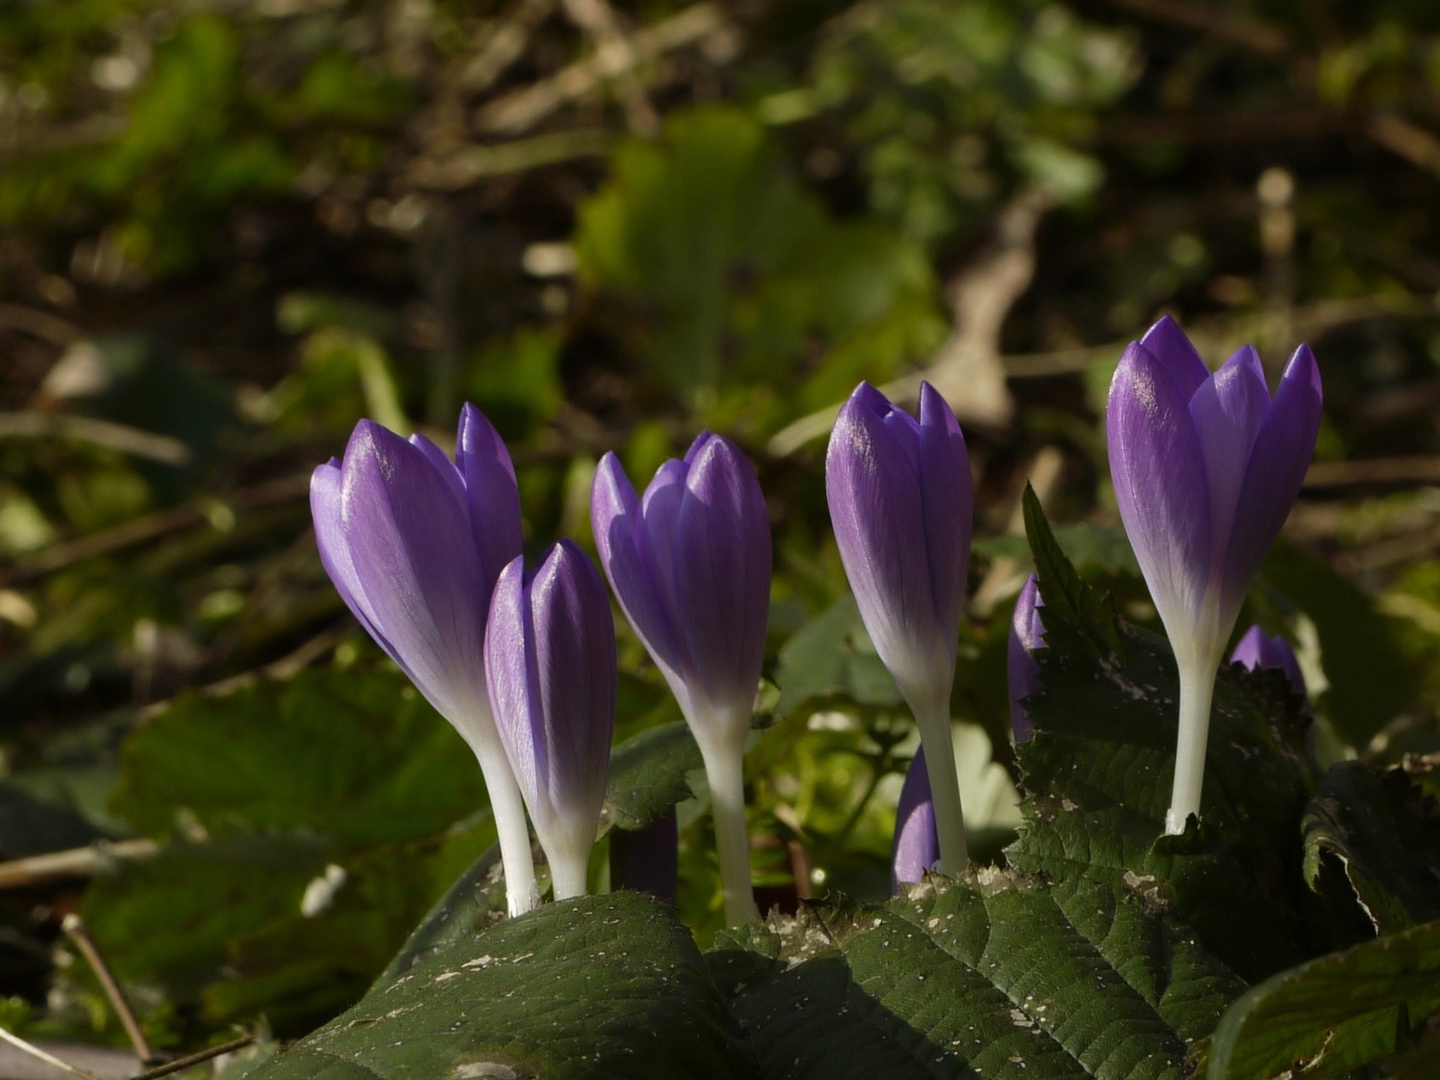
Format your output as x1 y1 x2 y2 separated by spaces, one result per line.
310 405 539 914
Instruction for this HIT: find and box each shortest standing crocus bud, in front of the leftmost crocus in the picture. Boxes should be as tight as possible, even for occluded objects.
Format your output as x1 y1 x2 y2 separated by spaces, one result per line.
485 540 618 900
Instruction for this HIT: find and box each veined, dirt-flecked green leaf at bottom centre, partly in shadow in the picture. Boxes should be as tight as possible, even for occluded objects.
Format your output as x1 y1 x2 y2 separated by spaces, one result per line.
717 871 1244 1080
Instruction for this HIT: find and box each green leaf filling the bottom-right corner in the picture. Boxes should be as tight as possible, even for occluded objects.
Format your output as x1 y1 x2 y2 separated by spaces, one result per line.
1205 923 1440 1080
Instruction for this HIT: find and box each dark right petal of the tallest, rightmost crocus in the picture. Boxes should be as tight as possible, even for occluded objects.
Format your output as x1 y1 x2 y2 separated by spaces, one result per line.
1221 346 1322 619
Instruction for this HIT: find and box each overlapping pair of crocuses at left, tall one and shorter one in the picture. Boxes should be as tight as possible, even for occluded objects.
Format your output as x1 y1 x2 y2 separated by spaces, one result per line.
310 405 616 914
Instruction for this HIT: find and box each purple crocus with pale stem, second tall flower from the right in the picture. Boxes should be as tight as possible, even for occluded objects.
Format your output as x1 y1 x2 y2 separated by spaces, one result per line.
825 383 972 874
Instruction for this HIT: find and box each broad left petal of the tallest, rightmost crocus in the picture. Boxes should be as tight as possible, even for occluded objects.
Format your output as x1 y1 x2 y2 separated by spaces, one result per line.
1104 343 1211 639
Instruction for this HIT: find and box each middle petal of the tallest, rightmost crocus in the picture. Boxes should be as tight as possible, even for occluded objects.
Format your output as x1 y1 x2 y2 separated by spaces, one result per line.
1189 346 1270 567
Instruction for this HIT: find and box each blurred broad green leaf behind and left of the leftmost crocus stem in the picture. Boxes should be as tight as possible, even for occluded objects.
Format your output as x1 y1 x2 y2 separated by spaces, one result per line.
111 668 485 848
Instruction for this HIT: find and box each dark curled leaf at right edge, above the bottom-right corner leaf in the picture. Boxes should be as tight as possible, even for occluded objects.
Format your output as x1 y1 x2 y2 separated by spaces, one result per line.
1302 762 1440 933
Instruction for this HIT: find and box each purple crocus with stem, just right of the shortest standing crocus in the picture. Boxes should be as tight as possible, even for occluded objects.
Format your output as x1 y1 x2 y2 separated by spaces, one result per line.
590 433 770 926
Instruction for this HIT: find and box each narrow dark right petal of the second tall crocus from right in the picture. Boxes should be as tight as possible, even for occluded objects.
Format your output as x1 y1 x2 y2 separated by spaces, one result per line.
916 383 973 665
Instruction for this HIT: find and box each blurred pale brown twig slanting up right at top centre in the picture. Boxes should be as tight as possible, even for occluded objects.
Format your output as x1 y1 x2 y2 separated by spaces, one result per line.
475 3 726 134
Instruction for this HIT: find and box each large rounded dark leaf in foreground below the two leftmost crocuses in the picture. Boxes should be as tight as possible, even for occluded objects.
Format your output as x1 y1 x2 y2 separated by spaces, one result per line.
239 893 753 1080
